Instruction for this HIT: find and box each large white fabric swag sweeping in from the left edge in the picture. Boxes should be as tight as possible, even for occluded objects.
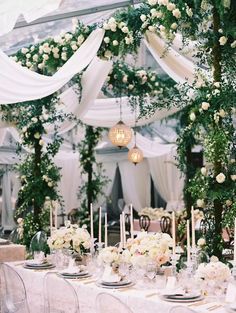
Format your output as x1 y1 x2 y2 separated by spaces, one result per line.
0 29 104 104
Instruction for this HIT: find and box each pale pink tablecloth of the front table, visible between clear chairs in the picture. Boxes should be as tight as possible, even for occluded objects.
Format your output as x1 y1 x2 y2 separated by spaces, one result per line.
8 262 225 313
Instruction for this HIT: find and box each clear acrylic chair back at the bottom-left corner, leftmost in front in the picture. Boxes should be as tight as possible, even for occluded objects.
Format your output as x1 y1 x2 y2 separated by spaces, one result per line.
0 263 29 313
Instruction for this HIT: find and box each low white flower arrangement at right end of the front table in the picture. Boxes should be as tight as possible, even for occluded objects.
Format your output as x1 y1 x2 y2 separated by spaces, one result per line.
196 261 231 283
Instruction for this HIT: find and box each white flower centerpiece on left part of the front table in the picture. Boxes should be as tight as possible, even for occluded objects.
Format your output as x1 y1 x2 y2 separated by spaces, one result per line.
47 223 91 254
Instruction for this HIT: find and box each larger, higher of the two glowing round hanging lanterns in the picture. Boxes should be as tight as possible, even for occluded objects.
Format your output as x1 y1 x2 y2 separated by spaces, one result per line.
108 121 132 148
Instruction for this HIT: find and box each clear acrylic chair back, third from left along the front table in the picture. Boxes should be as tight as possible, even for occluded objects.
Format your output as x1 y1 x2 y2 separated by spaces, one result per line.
96 292 133 313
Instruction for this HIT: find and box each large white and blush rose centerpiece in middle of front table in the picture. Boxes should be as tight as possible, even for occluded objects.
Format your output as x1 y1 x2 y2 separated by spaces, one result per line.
122 232 173 267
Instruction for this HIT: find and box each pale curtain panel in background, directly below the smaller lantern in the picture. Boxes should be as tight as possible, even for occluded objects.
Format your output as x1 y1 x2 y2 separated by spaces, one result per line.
119 160 151 211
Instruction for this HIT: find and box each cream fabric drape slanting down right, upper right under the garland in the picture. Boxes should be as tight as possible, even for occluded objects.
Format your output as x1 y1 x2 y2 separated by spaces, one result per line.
145 32 196 84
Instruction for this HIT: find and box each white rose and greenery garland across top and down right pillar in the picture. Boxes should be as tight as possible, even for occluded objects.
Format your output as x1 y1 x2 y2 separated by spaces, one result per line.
0 0 236 257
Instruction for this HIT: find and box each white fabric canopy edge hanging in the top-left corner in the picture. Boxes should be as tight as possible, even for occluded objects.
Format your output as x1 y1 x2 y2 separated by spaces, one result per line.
0 0 62 36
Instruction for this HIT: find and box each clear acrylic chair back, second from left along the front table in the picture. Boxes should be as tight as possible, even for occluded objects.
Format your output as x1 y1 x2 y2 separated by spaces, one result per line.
43 273 79 313
